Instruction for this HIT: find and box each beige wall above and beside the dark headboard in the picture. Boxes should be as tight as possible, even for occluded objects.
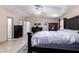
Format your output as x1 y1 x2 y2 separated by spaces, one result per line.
60 5 79 29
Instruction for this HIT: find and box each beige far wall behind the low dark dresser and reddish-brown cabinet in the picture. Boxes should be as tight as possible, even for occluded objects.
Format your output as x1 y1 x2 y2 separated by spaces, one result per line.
28 17 59 31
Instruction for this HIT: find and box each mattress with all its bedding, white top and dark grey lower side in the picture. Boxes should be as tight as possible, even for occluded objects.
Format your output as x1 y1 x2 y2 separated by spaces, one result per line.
31 30 79 51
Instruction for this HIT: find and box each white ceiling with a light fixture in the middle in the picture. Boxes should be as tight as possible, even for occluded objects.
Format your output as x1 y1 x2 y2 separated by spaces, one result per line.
5 5 73 17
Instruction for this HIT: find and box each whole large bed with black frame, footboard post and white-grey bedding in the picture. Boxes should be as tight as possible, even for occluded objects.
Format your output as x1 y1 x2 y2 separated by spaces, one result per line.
28 16 79 53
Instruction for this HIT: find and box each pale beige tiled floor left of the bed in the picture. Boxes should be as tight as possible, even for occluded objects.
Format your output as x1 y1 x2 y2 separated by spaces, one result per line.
0 37 27 53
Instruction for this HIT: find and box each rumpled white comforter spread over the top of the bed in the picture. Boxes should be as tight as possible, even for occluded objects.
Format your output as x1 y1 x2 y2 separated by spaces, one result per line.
32 30 79 46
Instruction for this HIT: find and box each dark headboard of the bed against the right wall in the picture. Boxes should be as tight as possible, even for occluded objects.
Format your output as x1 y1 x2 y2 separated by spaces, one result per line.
64 15 79 30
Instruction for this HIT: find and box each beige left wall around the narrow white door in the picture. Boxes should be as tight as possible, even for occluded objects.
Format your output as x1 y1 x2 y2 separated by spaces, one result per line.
0 6 21 42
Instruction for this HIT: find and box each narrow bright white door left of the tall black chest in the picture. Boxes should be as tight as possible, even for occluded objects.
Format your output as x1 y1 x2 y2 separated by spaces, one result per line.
8 17 13 38
